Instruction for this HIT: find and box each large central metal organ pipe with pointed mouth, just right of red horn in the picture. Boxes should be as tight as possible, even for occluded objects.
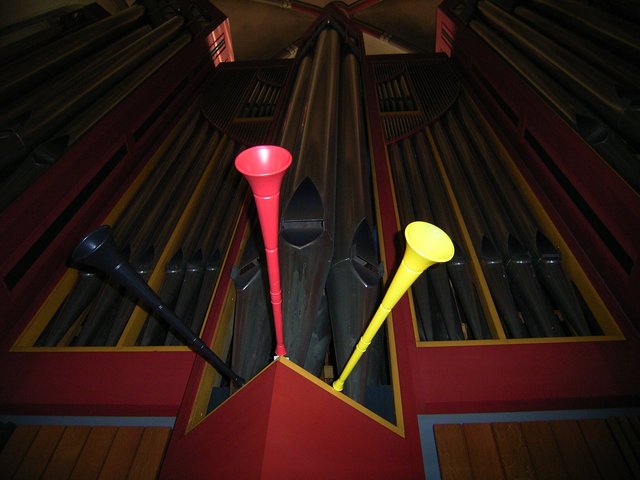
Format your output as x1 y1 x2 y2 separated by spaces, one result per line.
280 29 340 365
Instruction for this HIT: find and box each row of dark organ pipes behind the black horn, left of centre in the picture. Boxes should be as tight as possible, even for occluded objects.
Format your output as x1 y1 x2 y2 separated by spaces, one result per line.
37 102 246 346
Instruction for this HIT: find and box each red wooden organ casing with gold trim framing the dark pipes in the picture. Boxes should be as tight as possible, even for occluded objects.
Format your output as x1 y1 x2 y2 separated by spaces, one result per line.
0 2 640 478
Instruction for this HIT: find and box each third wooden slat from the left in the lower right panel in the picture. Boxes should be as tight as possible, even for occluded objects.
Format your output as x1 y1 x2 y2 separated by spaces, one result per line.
491 422 536 480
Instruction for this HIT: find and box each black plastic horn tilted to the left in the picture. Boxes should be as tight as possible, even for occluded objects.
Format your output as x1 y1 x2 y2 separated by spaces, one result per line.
71 225 244 387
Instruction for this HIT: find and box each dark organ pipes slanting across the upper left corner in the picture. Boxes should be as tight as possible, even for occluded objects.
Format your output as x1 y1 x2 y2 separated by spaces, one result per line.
0 5 204 211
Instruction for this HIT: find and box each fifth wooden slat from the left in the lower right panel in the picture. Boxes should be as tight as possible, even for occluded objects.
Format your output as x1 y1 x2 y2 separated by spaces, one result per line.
551 420 602 480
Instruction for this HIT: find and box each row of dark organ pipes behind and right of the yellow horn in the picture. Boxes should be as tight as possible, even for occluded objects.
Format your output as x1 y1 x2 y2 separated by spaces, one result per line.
388 90 601 340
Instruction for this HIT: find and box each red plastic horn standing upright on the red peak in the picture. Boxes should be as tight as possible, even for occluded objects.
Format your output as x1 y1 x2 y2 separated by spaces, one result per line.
236 145 291 357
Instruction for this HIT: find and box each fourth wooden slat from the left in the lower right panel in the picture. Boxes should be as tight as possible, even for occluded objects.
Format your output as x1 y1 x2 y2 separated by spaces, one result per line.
520 422 569 480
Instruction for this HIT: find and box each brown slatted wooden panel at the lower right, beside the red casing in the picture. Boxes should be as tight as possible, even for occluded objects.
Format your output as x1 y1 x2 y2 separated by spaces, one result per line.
434 417 640 480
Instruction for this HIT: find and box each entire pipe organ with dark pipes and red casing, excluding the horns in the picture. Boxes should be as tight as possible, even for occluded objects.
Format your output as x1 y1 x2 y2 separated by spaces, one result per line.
0 0 640 478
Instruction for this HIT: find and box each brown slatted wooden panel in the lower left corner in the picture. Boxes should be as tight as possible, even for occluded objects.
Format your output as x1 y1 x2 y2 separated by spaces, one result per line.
0 425 171 480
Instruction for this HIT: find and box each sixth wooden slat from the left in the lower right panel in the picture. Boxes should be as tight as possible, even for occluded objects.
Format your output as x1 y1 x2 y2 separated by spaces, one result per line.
578 419 632 480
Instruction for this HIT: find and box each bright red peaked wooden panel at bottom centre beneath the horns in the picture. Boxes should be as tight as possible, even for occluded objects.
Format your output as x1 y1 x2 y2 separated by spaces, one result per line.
161 361 424 479
